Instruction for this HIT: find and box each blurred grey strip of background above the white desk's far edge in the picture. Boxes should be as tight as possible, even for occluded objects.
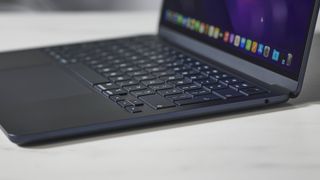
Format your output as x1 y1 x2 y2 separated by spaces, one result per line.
0 0 161 12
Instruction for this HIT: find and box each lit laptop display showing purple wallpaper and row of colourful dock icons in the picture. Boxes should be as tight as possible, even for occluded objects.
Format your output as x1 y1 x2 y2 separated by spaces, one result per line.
161 0 315 80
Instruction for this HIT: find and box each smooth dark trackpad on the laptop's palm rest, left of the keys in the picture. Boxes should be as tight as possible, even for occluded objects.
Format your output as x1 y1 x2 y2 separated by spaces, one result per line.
0 65 91 104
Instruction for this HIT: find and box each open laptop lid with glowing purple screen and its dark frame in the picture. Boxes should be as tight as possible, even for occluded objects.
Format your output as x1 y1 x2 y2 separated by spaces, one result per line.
159 0 319 97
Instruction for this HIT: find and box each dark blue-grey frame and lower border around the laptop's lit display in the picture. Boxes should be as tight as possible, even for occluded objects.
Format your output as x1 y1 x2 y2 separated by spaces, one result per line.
159 0 320 97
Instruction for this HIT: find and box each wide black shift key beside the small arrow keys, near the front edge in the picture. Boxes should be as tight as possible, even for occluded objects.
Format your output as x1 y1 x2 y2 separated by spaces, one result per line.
140 94 175 110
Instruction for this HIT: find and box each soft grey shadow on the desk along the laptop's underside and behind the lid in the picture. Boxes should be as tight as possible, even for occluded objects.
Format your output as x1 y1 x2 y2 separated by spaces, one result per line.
25 34 320 150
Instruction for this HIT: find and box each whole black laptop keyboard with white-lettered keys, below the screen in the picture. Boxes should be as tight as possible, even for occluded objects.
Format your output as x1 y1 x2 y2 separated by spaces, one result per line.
45 37 268 113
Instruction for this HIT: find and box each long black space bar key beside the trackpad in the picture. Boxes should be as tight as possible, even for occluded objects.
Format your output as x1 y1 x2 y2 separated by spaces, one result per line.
68 64 108 86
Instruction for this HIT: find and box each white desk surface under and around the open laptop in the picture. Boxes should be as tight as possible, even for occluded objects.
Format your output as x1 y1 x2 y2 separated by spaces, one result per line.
0 13 320 180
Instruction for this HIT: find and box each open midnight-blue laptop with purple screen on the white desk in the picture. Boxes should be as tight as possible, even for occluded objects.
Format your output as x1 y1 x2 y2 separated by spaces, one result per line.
0 0 319 145
